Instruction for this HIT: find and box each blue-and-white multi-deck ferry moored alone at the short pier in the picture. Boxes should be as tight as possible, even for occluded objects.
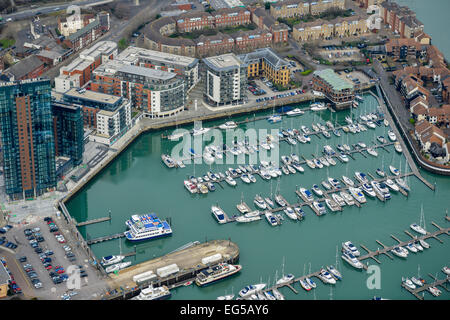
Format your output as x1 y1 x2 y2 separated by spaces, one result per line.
124 214 172 241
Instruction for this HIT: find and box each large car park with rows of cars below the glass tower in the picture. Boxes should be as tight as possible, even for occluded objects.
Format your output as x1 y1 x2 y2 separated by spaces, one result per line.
2 217 106 300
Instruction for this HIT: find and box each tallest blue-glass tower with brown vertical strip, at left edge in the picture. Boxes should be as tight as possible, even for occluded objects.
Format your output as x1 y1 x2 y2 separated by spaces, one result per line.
0 79 56 199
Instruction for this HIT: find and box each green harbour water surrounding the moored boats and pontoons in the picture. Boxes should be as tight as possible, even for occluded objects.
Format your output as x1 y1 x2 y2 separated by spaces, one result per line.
67 94 450 300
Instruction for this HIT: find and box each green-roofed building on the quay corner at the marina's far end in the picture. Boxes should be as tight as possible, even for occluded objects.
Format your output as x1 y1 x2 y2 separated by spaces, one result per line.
312 69 355 110
